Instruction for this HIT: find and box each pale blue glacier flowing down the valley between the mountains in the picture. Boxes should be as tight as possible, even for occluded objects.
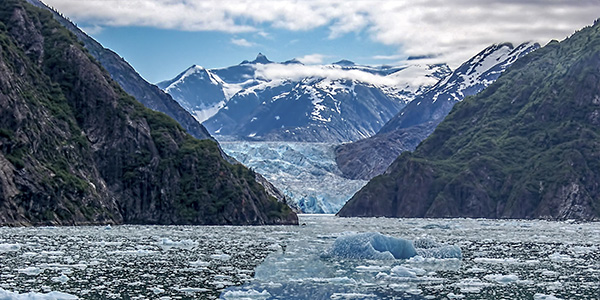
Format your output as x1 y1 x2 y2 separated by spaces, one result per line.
221 142 367 214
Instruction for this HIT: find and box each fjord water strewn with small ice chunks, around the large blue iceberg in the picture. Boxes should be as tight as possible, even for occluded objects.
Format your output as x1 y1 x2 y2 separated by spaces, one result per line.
0 215 600 300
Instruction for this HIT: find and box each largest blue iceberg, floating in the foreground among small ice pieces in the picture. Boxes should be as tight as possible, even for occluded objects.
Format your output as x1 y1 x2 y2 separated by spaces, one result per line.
323 232 462 260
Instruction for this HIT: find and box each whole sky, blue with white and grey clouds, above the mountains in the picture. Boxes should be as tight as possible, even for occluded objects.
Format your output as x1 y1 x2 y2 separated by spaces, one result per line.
43 0 600 83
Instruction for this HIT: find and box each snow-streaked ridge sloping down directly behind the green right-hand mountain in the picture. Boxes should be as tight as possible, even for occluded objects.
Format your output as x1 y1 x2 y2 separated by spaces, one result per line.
336 43 539 180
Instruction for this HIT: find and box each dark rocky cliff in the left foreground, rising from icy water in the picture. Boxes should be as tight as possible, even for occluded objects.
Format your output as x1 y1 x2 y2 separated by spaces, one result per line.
0 0 297 225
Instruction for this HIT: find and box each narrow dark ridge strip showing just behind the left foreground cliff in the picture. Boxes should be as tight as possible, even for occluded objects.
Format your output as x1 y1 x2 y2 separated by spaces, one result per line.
27 0 212 139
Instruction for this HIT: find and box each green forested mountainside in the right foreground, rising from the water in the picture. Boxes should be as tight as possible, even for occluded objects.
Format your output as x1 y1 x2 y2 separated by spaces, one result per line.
339 21 600 220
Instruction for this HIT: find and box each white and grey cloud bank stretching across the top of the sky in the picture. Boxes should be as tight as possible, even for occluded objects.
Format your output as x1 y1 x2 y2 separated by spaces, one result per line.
45 0 600 66
